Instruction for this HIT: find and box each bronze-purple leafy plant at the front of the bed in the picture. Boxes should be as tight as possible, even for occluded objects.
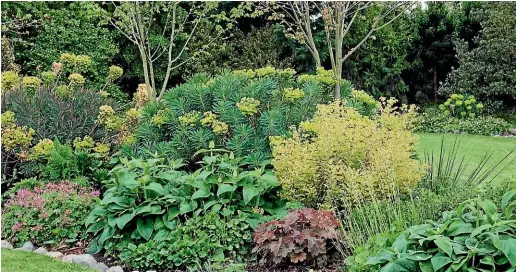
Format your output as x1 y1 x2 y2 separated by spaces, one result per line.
253 208 339 264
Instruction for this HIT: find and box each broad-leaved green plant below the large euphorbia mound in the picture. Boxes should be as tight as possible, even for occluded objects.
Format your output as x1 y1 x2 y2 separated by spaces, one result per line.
86 151 281 252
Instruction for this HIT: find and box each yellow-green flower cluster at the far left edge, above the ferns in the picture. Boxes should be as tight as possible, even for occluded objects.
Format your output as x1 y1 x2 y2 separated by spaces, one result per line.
2 111 35 151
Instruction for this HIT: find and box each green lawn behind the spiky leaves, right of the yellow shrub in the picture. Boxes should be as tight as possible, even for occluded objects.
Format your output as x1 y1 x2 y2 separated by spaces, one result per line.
416 133 516 185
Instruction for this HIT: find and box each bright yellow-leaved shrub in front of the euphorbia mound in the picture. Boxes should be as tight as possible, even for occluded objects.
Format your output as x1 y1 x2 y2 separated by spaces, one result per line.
271 99 425 208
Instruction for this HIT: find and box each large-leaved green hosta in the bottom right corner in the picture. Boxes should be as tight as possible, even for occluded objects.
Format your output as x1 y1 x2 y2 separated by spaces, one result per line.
367 190 516 272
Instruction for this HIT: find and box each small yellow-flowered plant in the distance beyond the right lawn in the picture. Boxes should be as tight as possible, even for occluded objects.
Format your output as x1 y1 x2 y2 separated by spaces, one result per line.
439 94 484 118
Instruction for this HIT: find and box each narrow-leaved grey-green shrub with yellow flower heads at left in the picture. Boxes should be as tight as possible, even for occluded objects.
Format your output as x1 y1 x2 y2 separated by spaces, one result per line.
2 54 119 142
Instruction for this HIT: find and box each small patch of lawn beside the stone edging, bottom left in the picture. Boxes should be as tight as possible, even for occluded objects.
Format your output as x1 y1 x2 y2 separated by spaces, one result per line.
2 248 96 272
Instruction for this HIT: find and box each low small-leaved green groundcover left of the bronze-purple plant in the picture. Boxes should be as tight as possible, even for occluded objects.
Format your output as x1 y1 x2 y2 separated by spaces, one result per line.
120 212 251 271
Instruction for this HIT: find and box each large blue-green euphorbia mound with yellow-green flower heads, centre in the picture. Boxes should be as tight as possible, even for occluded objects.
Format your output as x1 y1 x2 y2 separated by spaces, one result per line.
131 70 336 162
